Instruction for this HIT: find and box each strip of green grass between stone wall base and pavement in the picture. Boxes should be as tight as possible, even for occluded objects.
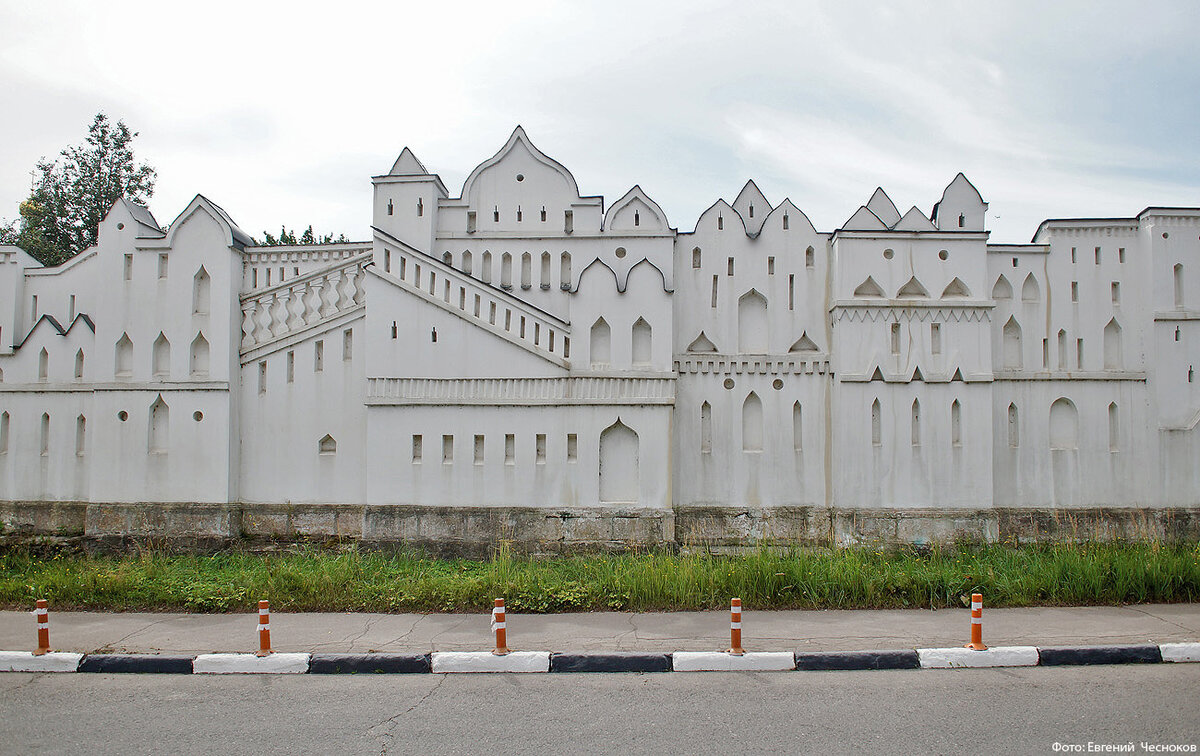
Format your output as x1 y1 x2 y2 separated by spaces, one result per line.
0 544 1200 612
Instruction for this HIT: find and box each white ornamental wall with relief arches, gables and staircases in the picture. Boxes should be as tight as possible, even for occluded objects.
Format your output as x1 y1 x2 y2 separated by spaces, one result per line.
0 128 1200 540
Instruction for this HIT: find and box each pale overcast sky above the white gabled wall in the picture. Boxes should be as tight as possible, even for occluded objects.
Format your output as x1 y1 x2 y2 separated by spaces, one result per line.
0 0 1200 242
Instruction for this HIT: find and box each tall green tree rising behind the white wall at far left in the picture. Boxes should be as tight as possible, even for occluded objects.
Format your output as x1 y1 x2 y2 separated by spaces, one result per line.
0 113 157 265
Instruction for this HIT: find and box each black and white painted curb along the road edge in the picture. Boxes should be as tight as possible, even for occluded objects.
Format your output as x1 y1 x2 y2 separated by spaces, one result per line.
0 643 1200 674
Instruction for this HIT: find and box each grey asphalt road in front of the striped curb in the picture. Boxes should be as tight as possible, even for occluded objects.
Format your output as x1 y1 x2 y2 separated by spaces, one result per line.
0 664 1200 756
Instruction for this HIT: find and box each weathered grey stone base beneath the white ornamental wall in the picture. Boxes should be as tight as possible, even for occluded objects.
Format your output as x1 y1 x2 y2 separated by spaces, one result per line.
0 502 1200 557
